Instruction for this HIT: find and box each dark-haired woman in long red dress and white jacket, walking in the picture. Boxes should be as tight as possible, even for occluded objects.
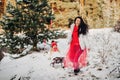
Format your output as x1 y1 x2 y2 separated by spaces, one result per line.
64 17 88 75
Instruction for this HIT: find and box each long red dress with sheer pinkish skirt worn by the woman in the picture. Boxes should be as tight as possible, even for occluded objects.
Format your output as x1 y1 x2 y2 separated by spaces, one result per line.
64 26 86 69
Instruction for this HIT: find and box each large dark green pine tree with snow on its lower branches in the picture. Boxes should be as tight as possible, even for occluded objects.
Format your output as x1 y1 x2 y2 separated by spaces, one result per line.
1 0 56 53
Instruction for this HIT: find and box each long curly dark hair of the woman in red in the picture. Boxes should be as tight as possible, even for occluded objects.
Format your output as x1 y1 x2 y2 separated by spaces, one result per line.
74 16 88 35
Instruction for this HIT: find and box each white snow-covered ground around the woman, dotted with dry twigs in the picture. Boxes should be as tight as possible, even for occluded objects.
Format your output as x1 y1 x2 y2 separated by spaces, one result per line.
0 28 120 80
